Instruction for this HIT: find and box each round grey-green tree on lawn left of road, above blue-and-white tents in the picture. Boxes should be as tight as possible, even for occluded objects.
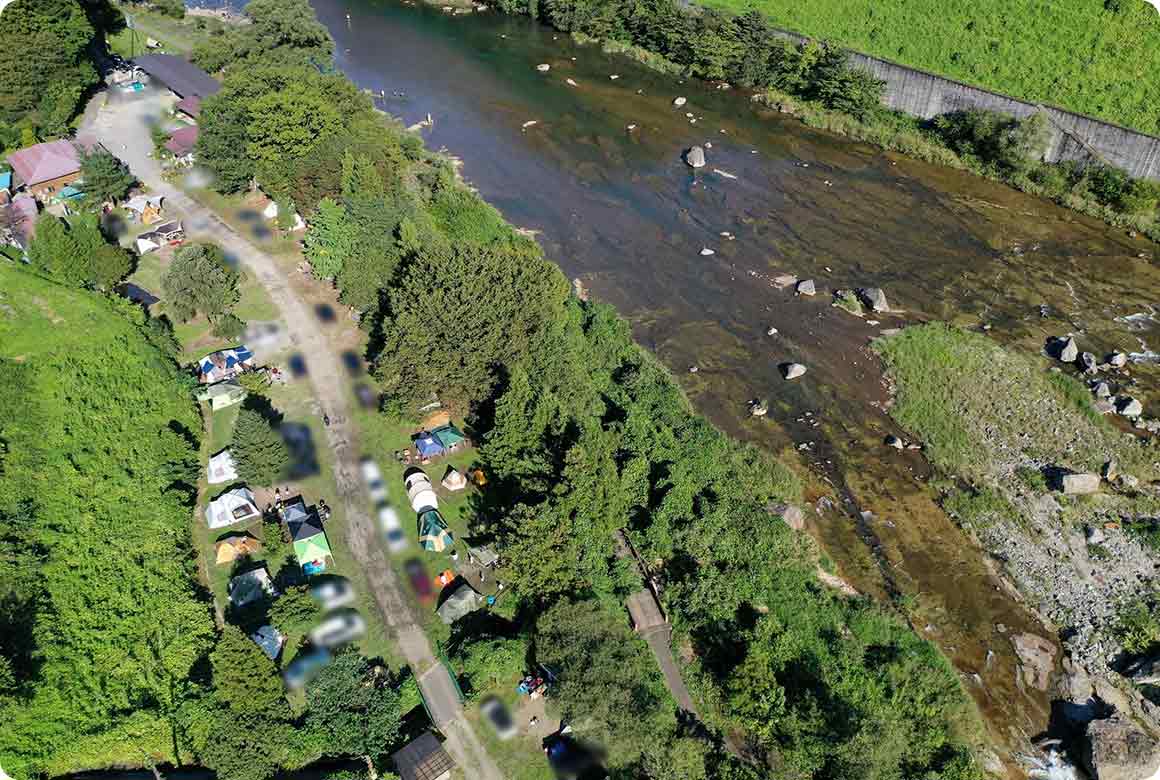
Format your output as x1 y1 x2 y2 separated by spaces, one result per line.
161 244 241 322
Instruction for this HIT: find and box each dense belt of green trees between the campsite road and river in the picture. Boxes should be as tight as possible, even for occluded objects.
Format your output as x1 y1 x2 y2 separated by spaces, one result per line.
185 0 979 780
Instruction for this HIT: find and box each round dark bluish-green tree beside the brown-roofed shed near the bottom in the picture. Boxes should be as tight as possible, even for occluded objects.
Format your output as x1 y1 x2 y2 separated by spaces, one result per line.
306 650 401 763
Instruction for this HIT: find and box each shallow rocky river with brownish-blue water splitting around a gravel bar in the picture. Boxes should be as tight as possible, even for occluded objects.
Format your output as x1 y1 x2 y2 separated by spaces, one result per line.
197 0 1160 758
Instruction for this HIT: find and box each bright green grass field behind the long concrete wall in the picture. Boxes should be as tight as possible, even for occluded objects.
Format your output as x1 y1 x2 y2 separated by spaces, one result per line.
701 0 1160 133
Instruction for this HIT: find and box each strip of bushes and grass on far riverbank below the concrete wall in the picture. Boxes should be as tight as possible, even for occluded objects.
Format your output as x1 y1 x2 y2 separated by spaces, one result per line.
482 0 1160 239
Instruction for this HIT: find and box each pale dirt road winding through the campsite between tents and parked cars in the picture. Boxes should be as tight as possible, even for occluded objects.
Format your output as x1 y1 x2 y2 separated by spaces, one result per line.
82 93 502 780
